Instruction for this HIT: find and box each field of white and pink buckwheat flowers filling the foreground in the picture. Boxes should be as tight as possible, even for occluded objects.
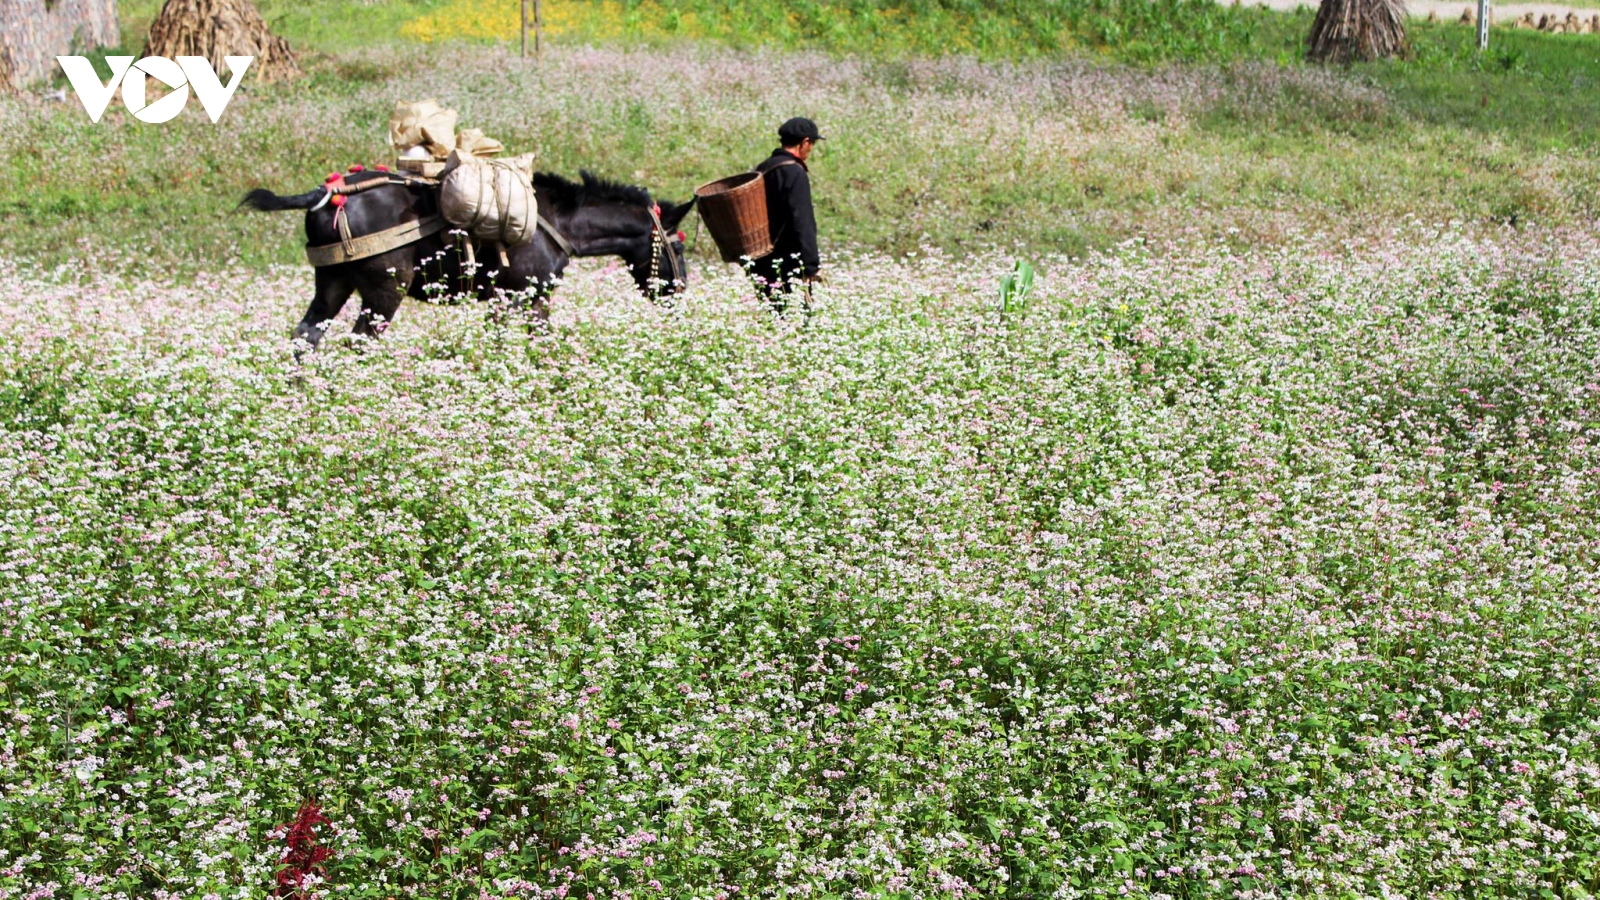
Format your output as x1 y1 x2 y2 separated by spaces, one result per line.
0 229 1600 900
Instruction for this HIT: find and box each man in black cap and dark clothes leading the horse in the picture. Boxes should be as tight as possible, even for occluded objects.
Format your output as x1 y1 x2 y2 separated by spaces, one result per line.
750 119 822 312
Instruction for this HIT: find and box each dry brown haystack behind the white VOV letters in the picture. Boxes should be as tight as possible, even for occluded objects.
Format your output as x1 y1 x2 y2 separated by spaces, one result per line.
144 0 299 82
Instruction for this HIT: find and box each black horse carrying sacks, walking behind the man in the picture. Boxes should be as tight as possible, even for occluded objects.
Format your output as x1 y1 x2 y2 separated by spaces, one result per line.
242 171 694 348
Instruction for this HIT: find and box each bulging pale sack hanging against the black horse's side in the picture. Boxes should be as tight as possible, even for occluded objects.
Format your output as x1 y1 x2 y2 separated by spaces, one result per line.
438 151 539 247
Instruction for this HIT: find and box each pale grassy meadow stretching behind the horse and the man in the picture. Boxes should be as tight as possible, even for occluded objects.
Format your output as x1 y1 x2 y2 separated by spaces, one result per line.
0 0 1600 277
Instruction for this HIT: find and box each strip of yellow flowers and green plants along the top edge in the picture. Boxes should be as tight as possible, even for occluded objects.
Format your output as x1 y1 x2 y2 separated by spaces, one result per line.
118 0 1251 59
